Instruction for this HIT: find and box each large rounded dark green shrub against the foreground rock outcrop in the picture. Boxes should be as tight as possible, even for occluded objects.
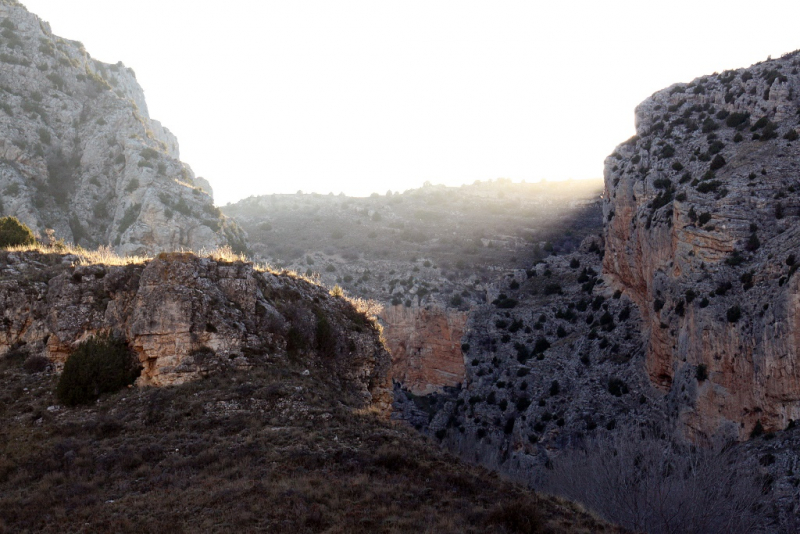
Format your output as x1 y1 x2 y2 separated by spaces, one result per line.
56 333 141 406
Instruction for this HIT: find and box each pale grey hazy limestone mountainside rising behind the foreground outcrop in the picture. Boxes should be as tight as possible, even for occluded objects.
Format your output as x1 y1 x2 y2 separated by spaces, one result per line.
0 0 244 254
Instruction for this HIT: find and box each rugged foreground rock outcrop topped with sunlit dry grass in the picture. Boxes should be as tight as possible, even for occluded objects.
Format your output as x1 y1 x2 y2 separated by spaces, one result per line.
0 251 391 410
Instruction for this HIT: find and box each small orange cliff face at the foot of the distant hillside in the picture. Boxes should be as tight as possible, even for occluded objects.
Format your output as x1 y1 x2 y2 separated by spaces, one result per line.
381 306 468 395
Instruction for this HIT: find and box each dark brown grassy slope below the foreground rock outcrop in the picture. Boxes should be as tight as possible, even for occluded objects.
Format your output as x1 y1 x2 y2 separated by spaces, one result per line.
0 357 632 534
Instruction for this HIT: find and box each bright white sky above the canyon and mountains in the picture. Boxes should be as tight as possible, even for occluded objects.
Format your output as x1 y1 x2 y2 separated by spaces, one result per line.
21 0 800 204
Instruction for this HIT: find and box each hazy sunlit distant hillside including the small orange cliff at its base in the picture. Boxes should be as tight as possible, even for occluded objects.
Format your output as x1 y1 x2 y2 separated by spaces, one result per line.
223 179 602 394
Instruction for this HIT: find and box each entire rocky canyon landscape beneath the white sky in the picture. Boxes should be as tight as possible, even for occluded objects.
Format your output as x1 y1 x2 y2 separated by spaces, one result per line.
0 0 800 533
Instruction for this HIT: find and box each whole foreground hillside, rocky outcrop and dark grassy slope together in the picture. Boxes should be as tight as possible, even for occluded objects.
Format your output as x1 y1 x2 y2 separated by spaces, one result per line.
0 251 622 533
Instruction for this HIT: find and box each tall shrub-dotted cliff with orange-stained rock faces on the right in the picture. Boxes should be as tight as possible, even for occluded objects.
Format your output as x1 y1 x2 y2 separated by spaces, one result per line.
604 53 800 438
